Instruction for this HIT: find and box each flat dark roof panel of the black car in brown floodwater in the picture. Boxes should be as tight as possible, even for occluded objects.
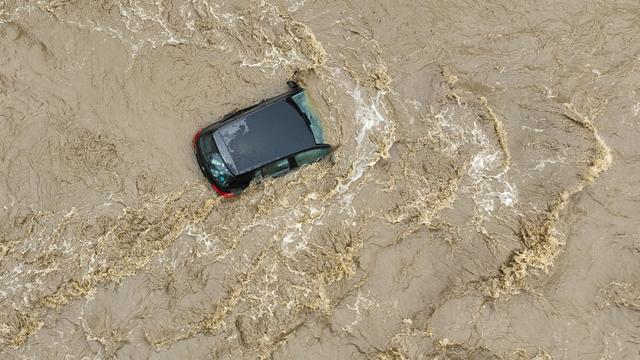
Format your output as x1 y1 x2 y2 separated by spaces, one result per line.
213 95 317 175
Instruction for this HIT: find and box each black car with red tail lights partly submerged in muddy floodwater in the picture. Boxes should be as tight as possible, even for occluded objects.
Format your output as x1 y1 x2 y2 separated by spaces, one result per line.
193 81 332 197
